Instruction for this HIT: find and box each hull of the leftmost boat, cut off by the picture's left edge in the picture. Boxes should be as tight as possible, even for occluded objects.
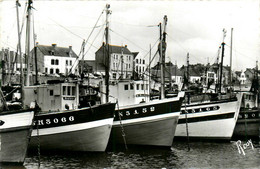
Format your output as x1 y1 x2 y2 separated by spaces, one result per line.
0 110 34 163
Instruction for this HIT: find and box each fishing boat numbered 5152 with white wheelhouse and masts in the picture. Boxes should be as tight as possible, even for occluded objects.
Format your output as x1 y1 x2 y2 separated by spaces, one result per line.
97 16 184 147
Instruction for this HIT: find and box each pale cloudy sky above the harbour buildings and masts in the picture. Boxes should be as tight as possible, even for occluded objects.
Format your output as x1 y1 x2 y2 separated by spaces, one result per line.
0 0 260 71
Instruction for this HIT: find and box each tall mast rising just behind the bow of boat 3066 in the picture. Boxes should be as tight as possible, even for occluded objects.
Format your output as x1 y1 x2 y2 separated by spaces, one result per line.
105 4 111 102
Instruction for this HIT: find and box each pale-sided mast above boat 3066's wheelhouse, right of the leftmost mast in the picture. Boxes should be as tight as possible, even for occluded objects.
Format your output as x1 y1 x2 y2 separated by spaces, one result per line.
25 0 32 86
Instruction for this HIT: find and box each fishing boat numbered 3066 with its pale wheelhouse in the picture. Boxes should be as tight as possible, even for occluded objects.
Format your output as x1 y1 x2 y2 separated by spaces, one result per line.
25 82 115 151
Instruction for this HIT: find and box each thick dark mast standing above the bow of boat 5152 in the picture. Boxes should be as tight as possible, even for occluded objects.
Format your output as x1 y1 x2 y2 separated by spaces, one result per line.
159 15 167 99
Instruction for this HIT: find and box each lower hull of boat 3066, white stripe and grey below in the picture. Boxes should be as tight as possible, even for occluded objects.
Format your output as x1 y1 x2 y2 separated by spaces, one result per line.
30 118 113 151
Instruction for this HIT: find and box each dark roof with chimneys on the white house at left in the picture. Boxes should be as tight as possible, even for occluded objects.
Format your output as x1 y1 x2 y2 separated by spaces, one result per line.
37 44 78 58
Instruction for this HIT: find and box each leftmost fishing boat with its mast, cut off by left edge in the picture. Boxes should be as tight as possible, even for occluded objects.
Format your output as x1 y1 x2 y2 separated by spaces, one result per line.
0 1 36 164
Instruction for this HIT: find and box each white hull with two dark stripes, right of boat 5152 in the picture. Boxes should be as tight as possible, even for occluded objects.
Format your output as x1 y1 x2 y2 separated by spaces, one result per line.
175 94 242 140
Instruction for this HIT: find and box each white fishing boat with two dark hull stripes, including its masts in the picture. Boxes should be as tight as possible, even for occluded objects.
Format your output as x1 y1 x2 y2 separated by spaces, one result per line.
175 30 242 140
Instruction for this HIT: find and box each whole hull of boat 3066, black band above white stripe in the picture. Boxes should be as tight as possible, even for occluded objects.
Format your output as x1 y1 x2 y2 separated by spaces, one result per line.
30 103 115 151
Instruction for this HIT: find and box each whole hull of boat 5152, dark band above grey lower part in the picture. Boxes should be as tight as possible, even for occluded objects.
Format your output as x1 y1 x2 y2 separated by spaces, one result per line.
110 97 183 147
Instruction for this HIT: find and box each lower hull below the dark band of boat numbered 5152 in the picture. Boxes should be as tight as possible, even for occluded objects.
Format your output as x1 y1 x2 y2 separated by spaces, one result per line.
111 112 180 146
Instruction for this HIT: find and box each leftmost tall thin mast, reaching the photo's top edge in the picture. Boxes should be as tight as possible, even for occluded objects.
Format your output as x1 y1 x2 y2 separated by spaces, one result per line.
16 0 24 107
